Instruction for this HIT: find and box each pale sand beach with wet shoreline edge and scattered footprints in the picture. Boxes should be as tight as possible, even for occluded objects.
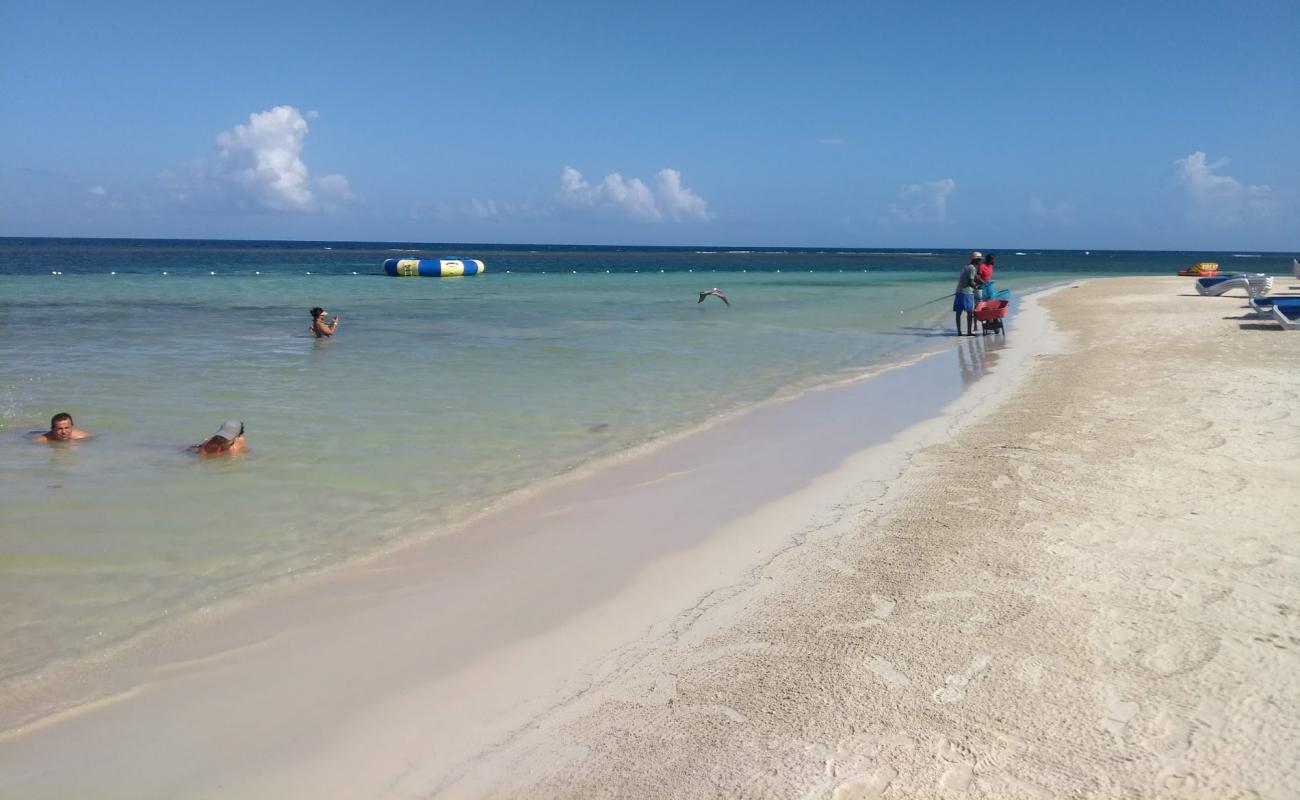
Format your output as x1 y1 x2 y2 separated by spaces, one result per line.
0 277 1300 800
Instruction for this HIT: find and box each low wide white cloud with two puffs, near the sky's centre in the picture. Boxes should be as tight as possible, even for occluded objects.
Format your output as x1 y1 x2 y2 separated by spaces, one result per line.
556 167 714 222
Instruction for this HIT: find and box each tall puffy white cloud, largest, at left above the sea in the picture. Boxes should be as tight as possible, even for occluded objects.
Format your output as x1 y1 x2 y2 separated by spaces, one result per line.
163 105 355 212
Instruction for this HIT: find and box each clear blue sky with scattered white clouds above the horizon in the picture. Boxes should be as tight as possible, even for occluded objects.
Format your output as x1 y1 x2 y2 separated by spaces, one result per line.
0 0 1300 251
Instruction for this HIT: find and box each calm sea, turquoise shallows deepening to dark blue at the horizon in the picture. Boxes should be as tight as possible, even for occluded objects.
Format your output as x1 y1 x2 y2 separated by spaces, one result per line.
0 239 1290 686
